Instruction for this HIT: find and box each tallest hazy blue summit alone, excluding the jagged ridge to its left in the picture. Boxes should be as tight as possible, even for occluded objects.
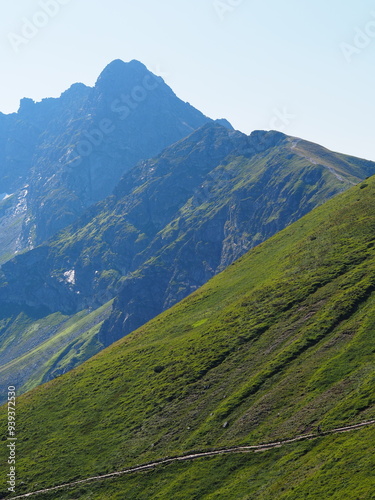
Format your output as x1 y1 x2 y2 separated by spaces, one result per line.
25 60 210 244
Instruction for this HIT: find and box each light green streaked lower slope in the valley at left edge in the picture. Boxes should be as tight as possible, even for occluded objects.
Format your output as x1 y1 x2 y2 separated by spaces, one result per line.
0 302 112 401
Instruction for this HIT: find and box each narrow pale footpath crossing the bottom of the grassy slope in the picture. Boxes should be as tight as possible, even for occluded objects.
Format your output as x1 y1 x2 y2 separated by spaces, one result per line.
9 420 375 500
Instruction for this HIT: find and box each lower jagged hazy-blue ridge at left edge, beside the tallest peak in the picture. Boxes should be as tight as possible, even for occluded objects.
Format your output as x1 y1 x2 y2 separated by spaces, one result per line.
0 85 89 264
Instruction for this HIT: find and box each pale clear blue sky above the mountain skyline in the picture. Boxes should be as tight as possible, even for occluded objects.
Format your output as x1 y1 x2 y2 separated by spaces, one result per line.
0 0 375 160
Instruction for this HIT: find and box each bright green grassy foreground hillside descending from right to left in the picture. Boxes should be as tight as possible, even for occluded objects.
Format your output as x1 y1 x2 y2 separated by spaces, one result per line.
0 169 375 500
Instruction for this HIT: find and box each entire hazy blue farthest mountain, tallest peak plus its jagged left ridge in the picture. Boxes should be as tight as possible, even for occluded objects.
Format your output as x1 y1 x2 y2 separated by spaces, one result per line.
0 60 210 260
